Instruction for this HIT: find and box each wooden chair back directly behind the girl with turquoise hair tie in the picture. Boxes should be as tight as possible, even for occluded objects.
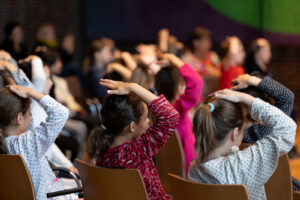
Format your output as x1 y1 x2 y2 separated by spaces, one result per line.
169 173 249 200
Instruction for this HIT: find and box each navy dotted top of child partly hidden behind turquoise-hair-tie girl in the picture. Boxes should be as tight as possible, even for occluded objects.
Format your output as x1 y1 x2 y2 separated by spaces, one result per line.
243 76 294 143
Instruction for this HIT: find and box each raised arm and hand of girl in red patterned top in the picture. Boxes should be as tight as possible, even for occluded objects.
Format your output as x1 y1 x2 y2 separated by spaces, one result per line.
100 79 179 156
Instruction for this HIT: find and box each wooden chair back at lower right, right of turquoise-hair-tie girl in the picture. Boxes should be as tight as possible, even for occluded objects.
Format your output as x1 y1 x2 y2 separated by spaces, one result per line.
240 143 293 200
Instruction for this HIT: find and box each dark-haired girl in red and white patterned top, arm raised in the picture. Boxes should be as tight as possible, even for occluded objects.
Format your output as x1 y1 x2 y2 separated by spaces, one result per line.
88 79 179 199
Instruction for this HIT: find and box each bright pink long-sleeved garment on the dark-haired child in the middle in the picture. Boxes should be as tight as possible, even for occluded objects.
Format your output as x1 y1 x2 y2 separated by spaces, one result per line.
174 64 203 173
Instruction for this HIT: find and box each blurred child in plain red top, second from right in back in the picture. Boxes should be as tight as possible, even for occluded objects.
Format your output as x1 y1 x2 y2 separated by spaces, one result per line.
220 36 245 90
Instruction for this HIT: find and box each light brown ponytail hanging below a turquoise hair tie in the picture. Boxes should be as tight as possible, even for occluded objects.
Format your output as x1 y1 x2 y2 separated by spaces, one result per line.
193 104 216 161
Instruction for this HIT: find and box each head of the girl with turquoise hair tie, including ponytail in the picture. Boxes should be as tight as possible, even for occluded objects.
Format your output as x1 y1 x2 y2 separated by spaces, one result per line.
193 97 246 162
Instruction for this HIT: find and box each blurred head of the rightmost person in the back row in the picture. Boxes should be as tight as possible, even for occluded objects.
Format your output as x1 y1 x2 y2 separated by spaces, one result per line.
251 38 272 64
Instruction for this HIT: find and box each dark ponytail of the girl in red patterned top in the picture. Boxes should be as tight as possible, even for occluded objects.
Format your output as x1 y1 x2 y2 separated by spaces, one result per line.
87 125 113 159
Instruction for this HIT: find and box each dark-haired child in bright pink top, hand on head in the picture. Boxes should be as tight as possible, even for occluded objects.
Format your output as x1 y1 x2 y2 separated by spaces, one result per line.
155 54 203 173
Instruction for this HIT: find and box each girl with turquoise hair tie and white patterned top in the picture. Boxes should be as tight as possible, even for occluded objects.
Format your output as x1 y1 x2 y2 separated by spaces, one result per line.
189 89 296 199
